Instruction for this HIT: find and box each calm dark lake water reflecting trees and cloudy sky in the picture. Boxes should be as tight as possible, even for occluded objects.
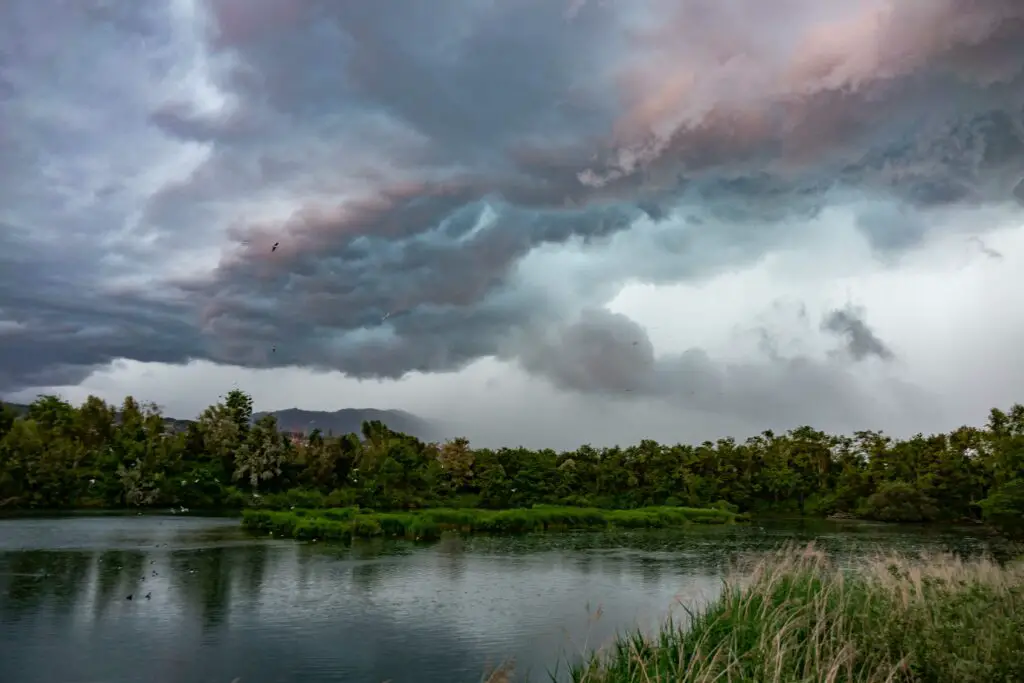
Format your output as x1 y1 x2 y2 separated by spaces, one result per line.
0 515 997 683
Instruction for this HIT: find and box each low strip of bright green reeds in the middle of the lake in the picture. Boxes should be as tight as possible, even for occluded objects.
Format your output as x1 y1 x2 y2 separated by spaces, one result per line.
242 506 745 541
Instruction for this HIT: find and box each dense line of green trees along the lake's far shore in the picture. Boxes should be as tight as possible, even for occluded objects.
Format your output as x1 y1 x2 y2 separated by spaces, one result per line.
0 390 1024 528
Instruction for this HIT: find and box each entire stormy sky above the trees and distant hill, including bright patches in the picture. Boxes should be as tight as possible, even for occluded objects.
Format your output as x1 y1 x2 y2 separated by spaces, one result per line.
0 0 1024 447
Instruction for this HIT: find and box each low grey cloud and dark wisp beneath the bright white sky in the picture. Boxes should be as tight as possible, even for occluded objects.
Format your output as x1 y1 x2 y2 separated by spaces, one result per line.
510 309 920 424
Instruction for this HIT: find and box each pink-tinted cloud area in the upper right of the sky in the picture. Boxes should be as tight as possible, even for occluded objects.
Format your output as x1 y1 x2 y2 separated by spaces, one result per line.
598 0 1024 179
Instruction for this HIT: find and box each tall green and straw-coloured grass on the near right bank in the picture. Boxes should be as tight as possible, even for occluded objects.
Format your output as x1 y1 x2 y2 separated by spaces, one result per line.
570 548 1024 683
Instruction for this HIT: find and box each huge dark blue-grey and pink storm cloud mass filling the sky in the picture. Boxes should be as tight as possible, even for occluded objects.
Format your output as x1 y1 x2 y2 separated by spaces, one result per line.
0 0 1024 432
